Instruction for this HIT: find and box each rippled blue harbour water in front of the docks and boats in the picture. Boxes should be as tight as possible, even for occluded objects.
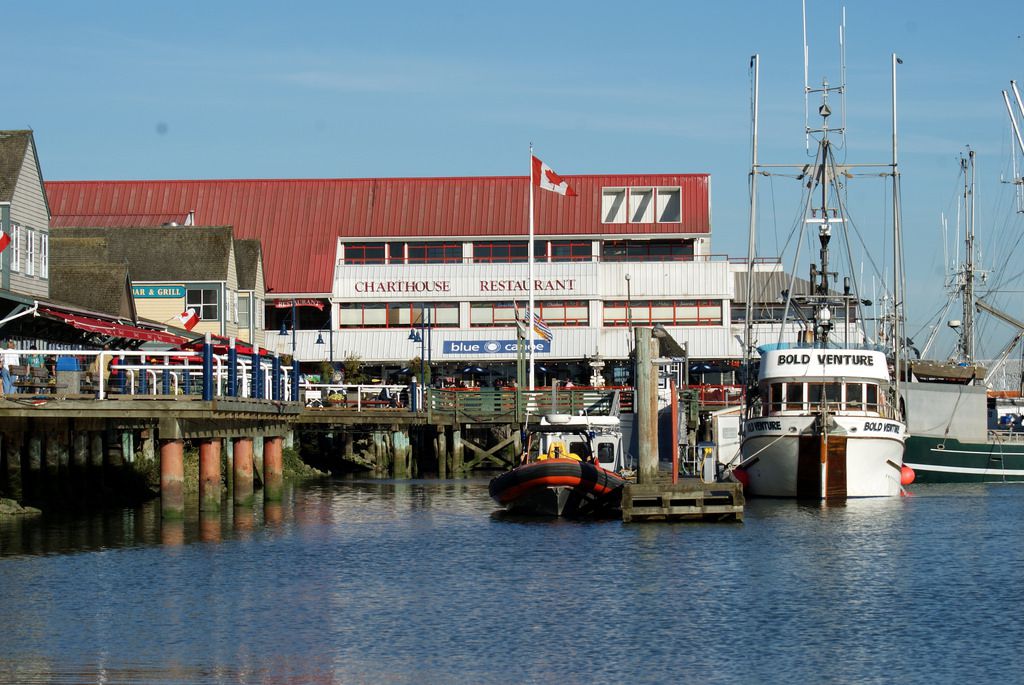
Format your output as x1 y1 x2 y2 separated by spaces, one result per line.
0 480 1024 684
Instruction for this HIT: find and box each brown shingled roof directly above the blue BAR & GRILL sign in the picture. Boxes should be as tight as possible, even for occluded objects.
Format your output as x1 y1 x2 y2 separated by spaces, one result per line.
50 226 232 283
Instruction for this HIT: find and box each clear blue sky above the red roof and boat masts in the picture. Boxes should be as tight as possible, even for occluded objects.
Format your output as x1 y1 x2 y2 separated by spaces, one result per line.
8 0 1024 354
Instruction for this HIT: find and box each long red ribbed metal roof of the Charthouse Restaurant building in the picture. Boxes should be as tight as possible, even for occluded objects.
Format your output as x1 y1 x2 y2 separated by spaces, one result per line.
46 174 711 293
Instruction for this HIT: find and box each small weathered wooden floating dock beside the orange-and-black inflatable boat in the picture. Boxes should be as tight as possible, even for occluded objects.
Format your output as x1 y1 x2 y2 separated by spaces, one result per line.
622 478 744 523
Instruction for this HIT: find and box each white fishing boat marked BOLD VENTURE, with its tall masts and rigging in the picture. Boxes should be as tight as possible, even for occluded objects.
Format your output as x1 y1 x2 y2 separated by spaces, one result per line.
734 12 906 500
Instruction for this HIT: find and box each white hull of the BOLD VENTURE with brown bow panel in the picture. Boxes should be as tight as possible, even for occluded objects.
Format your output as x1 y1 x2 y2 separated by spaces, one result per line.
740 416 905 500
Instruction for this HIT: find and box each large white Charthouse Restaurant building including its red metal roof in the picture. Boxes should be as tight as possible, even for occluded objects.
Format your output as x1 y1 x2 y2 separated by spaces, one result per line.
46 174 742 384
